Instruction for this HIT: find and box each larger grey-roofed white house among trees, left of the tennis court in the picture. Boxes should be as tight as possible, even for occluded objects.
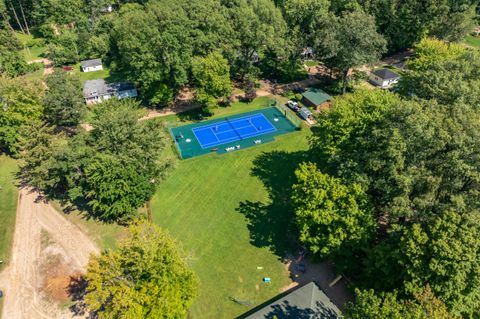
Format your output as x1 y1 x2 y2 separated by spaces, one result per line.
83 79 138 104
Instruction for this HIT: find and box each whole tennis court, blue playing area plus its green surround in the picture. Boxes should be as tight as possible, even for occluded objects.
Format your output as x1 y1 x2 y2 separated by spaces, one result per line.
170 107 297 159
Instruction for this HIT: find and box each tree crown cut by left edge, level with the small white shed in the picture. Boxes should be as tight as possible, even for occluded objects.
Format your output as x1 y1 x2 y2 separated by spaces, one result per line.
0 26 27 76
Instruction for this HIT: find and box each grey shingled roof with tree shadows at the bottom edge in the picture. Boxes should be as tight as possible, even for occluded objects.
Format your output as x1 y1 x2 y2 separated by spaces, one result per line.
240 282 341 319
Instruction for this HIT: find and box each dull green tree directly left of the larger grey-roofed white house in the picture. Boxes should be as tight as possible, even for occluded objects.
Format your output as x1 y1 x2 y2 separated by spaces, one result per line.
43 70 86 126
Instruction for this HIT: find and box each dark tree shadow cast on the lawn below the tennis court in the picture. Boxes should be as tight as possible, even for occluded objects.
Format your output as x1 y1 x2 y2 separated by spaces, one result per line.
236 151 311 260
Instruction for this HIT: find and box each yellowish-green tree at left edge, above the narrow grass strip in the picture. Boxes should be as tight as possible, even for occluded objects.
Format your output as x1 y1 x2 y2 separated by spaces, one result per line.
0 76 43 153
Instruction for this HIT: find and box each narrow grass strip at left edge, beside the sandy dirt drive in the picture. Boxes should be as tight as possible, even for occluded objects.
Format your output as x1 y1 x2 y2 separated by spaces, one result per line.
0 155 18 270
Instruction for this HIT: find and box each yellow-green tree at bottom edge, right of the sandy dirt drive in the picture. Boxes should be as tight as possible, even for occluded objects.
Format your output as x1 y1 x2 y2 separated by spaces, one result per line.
85 223 197 319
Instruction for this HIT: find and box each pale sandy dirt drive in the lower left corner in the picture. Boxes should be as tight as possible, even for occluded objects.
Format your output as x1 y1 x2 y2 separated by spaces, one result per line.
0 189 99 319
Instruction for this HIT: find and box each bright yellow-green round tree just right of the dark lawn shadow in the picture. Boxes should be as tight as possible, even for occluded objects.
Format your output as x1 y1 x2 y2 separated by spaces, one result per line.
292 163 375 259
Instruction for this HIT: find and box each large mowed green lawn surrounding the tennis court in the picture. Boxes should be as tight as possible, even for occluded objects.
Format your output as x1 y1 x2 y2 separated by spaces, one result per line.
151 99 309 319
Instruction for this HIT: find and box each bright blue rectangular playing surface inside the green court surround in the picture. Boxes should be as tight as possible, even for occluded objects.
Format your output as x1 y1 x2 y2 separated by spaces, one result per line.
192 113 277 149
